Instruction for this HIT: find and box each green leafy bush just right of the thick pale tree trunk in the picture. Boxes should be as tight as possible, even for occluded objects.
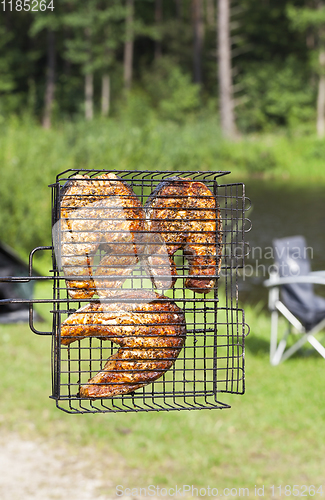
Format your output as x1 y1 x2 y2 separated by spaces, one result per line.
237 59 315 132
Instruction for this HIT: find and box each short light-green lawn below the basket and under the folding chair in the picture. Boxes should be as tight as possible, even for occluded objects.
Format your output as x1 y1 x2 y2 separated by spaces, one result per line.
0 300 325 498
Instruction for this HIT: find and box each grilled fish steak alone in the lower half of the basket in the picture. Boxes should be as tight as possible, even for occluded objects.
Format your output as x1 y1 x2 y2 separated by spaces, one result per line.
61 290 186 398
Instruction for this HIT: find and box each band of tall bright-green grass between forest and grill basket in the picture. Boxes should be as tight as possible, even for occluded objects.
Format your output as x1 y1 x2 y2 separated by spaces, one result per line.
0 114 325 255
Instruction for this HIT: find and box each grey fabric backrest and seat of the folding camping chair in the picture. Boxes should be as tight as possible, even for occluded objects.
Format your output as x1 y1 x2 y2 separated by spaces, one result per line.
273 236 325 331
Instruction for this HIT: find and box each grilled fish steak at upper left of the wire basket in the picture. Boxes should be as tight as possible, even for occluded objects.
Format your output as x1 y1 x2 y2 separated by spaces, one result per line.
59 173 145 299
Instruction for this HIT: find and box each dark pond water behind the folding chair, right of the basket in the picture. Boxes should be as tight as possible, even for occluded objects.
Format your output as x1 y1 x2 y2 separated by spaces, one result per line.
228 179 325 305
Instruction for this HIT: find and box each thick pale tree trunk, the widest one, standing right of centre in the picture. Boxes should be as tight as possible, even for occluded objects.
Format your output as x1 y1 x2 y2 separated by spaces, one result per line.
217 0 236 138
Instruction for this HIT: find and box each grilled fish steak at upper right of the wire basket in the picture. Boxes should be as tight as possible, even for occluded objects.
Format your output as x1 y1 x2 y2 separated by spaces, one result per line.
145 177 222 293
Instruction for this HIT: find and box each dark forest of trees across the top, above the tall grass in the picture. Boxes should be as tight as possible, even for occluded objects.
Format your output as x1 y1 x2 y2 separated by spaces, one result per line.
0 0 325 137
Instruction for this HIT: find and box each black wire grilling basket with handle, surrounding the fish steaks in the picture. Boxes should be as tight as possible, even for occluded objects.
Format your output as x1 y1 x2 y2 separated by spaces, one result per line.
0 169 250 413
